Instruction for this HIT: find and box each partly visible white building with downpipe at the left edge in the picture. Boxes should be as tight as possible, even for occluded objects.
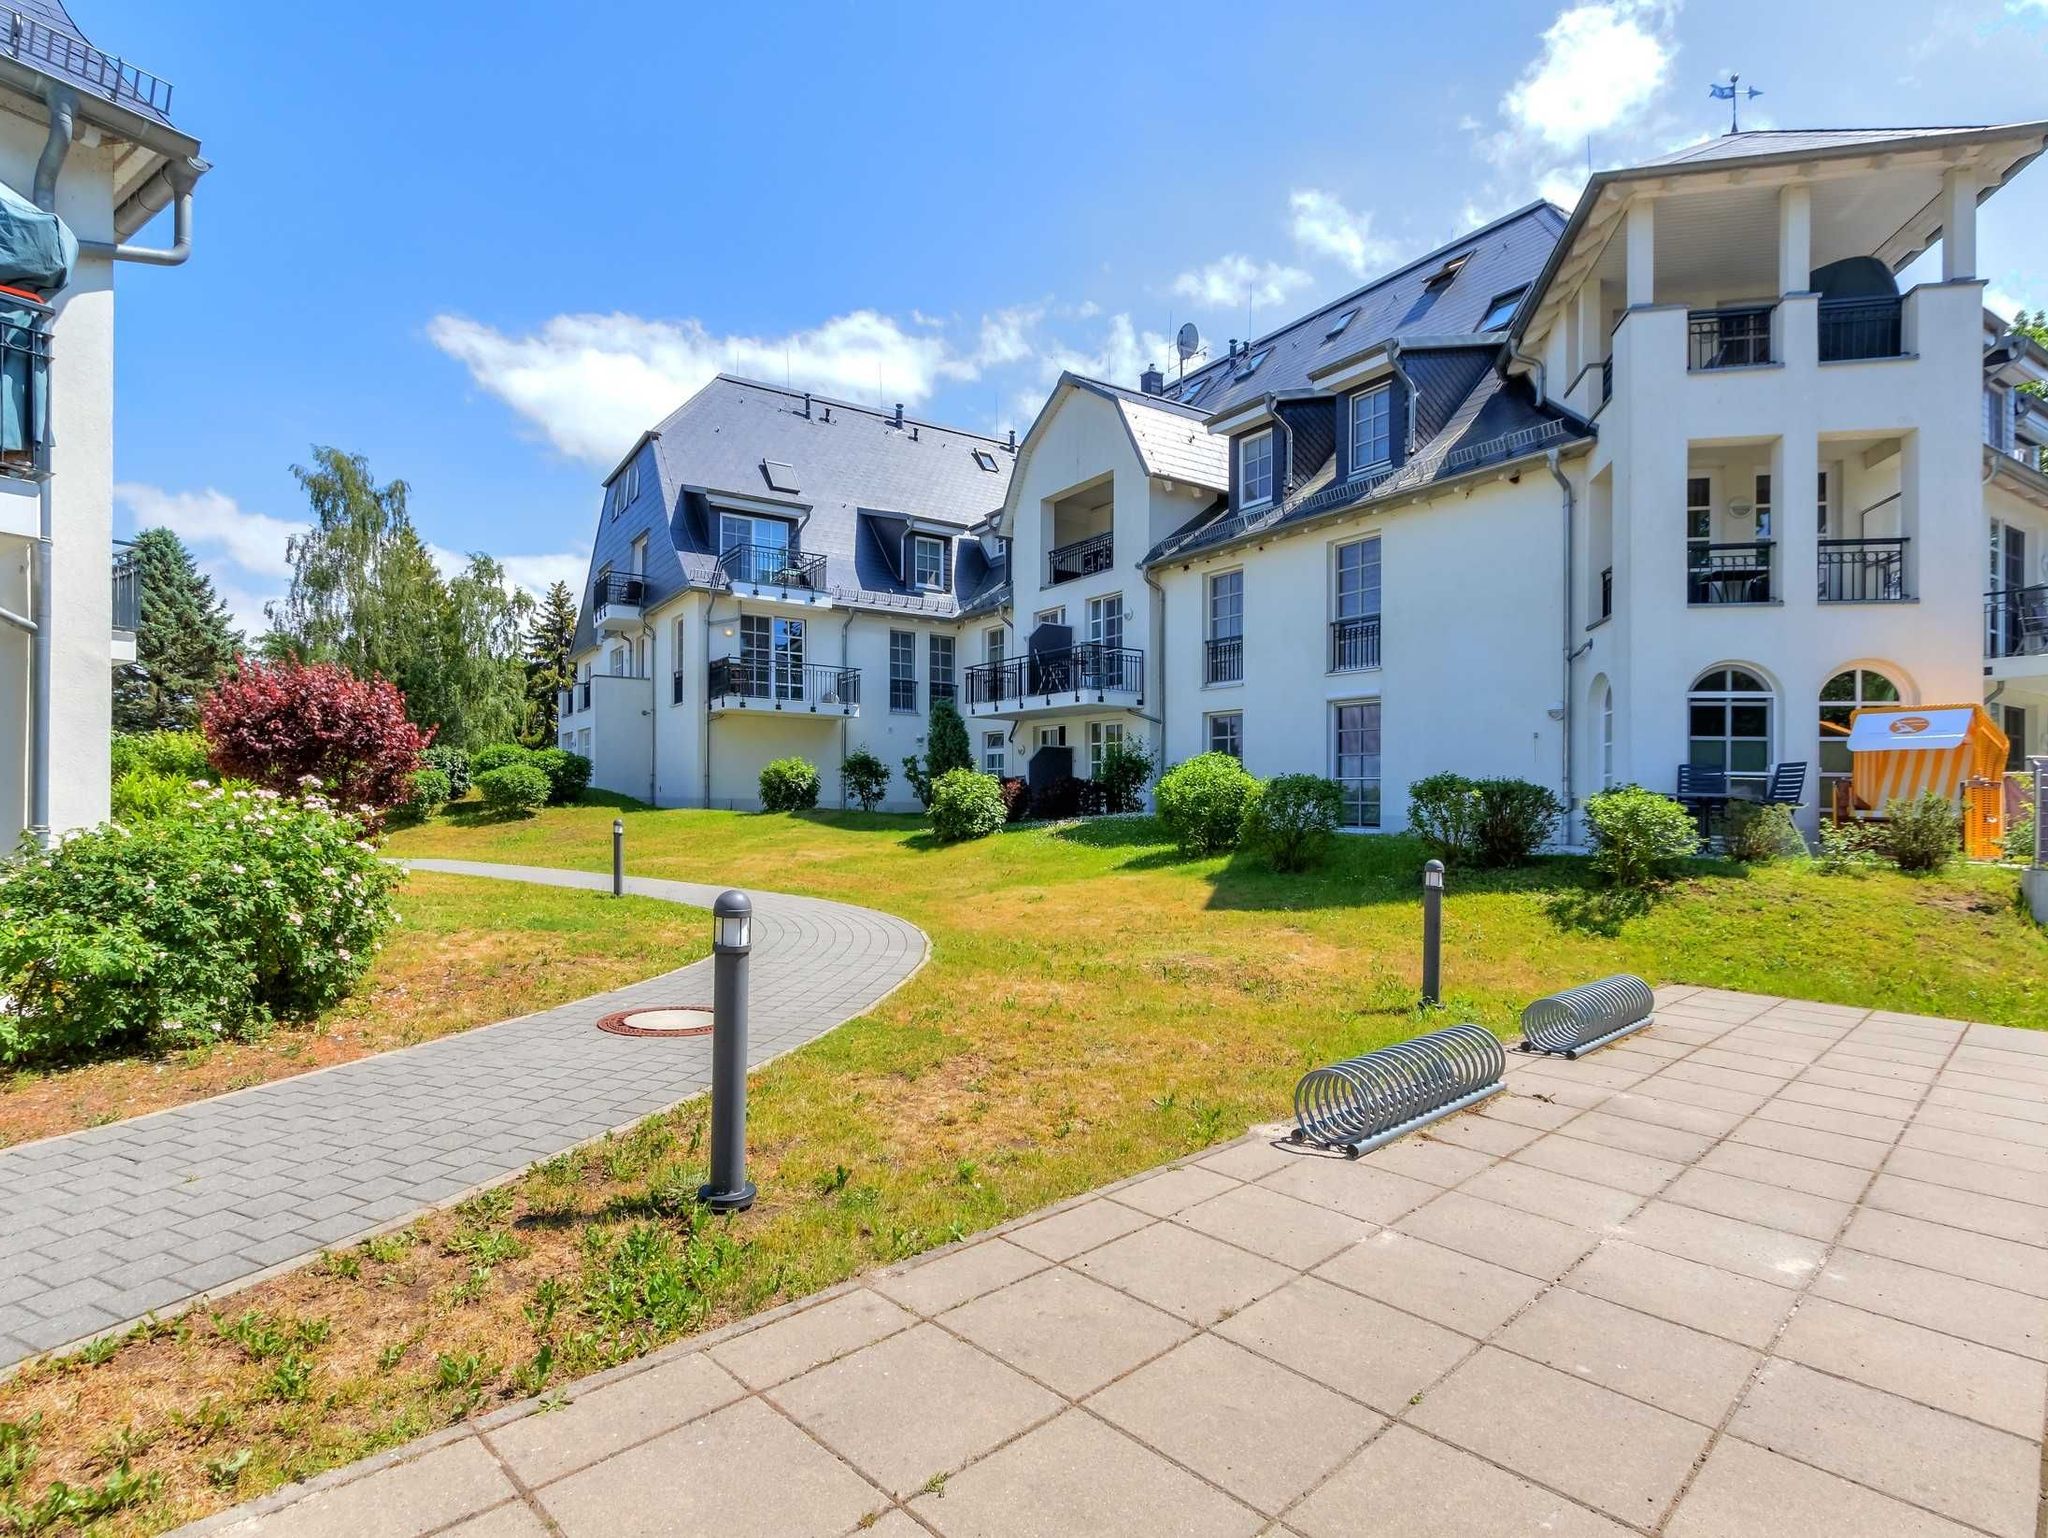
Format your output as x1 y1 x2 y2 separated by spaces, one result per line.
0 0 207 852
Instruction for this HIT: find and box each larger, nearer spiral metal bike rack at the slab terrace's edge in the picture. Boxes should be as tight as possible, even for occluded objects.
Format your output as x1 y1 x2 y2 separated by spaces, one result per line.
1288 1026 1507 1159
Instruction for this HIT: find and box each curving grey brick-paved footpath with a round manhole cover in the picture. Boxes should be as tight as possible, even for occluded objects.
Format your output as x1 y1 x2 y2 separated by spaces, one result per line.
0 860 926 1366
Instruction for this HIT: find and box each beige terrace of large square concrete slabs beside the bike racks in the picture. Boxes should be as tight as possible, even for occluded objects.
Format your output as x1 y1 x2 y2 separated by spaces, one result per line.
188 989 2048 1538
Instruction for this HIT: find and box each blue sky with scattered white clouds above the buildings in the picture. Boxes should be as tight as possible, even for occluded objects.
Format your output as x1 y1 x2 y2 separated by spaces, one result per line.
88 0 2048 627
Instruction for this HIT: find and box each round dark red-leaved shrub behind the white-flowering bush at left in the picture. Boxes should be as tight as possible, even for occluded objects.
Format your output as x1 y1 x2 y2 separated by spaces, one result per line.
199 657 430 811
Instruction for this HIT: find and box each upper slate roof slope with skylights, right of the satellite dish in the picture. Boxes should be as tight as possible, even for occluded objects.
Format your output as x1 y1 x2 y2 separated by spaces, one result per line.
1169 203 1565 428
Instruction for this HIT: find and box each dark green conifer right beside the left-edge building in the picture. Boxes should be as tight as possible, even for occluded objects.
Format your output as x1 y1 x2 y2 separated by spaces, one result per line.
115 528 242 731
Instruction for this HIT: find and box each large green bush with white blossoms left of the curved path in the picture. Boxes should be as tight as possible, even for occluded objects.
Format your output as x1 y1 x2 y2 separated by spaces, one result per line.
0 782 399 1063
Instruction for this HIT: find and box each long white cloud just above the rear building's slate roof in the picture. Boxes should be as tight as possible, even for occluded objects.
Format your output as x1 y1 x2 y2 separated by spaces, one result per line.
428 309 978 469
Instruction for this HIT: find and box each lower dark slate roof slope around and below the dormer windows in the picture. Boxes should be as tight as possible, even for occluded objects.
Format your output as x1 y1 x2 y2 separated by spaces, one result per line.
1145 342 1593 565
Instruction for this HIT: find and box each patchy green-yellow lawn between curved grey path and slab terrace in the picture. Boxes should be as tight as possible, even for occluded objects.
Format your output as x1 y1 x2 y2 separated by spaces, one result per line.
0 803 2048 1532
